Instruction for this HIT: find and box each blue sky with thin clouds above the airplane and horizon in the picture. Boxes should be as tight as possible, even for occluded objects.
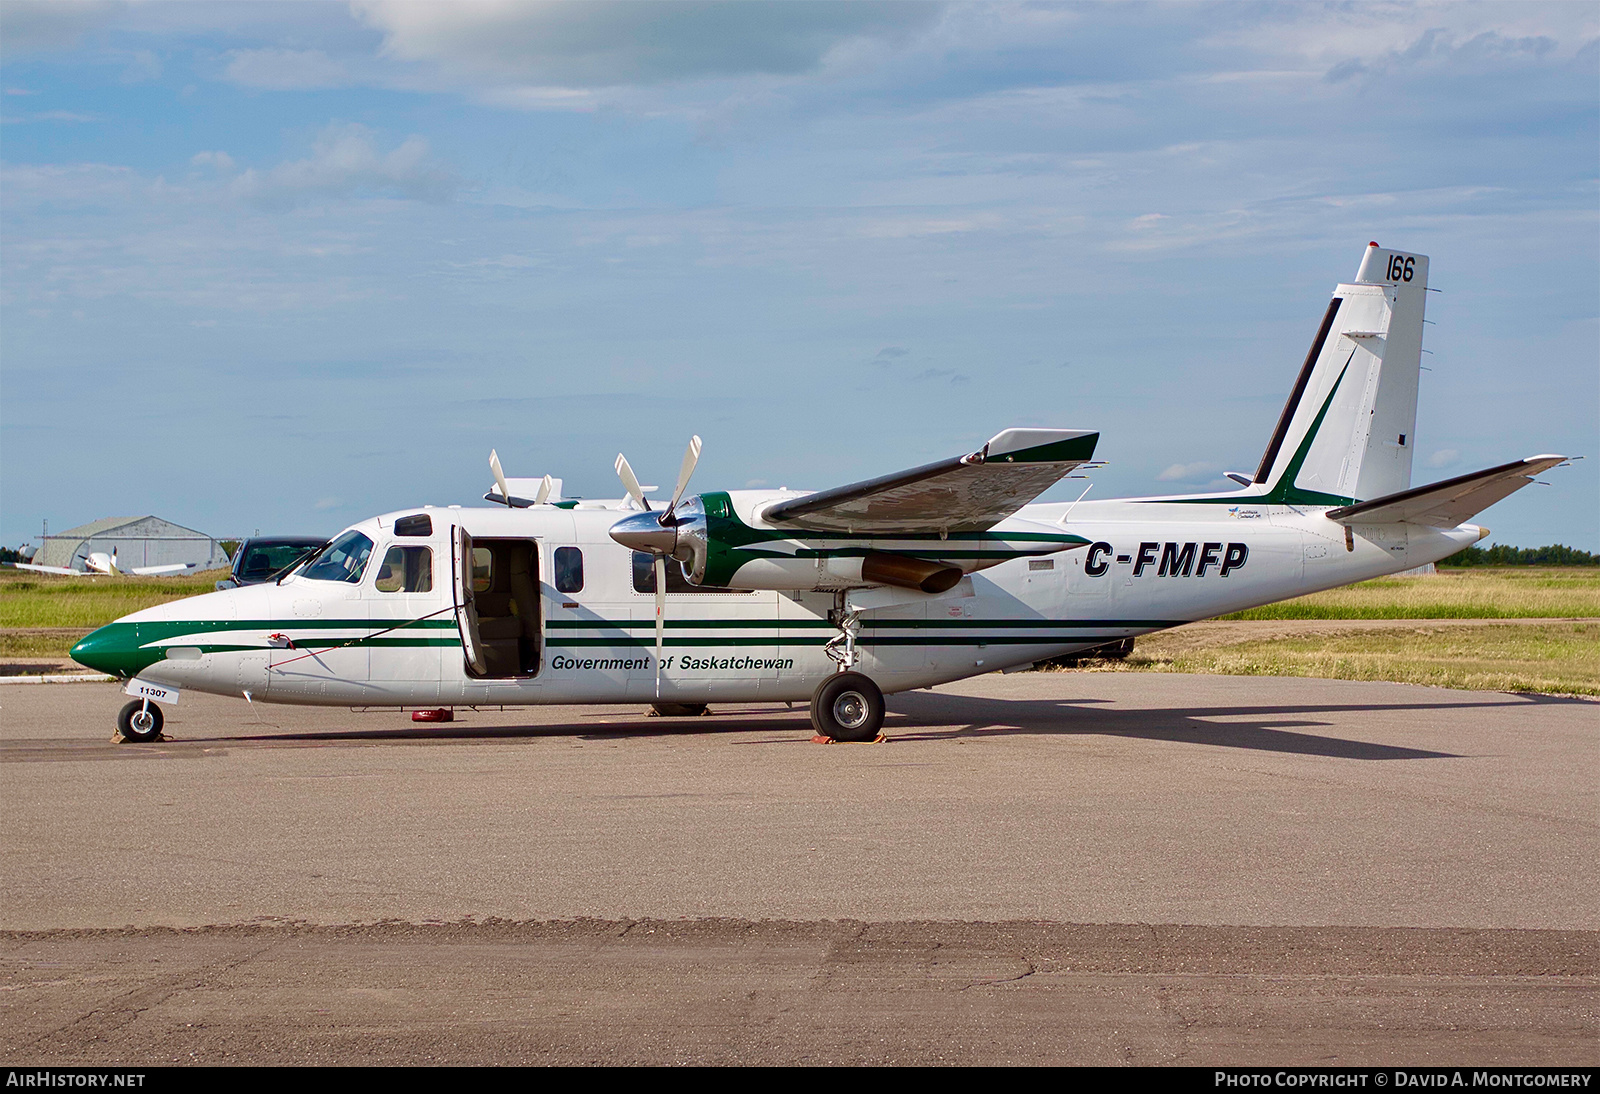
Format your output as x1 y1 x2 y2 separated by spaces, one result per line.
0 0 1600 550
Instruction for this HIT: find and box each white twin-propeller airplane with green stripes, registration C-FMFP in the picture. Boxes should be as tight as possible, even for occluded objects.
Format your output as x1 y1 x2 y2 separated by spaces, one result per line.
72 243 1566 742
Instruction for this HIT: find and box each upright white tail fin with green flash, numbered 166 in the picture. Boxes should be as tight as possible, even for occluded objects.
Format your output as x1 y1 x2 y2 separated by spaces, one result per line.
1254 243 1427 505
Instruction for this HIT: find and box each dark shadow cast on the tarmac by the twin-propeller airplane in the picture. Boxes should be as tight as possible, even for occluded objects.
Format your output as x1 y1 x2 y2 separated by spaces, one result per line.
156 691 1555 760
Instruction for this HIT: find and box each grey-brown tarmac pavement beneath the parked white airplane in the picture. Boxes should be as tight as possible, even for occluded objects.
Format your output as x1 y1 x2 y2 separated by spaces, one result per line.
0 673 1600 1065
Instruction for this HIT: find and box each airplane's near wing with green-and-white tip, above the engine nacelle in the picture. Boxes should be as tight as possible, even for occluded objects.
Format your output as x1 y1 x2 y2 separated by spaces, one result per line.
762 429 1099 533
